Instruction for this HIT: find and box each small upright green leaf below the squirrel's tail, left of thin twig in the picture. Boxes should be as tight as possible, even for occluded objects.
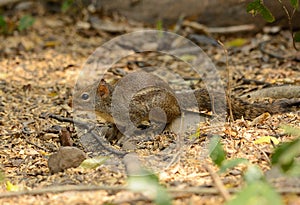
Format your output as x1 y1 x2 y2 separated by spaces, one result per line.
209 136 226 167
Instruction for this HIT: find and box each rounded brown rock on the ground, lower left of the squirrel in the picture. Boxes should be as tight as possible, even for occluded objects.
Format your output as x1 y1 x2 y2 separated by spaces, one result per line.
48 147 86 174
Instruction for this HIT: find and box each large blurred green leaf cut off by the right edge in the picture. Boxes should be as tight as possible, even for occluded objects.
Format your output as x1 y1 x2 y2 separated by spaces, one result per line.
271 138 300 172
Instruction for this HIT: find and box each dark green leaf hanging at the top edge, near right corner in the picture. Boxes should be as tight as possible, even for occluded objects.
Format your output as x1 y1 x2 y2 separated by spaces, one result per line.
247 0 275 23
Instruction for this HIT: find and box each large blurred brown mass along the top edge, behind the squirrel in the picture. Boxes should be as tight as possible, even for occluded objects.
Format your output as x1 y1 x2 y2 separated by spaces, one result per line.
96 0 300 29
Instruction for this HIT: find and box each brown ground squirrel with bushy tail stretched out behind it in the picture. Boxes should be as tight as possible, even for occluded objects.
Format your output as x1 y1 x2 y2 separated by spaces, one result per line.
74 71 300 138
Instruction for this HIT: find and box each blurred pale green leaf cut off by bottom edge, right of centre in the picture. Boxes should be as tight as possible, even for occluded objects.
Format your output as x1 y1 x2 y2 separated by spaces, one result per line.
226 181 283 205
